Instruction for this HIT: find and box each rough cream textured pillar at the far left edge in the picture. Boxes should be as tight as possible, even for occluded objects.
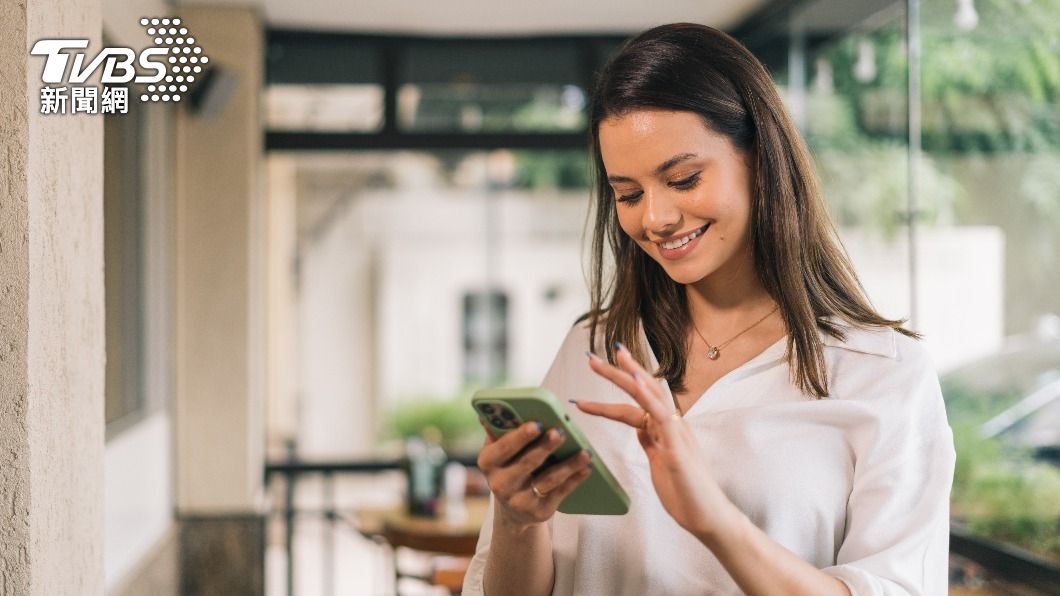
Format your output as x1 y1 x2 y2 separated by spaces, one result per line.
0 0 104 596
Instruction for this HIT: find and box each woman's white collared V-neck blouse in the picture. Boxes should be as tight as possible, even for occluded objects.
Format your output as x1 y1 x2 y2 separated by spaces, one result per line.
463 318 955 596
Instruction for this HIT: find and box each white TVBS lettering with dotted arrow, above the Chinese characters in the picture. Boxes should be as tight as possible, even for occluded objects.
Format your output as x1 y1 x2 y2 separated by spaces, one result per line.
30 18 210 110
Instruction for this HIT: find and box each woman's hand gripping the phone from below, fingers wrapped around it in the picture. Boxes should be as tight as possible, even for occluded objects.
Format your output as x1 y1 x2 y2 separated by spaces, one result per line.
478 421 591 528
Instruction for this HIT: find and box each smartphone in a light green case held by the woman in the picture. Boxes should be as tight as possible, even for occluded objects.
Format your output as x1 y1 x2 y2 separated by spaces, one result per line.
471 387 630 515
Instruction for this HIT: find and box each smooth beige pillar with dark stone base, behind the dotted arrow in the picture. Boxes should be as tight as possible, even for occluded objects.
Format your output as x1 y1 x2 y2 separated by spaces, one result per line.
175 4 265 595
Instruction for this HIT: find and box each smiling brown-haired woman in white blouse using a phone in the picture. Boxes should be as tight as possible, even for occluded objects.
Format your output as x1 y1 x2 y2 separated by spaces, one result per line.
464 23 954 596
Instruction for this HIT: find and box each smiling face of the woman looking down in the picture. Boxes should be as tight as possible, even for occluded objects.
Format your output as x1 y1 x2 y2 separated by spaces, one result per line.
598 109 753 284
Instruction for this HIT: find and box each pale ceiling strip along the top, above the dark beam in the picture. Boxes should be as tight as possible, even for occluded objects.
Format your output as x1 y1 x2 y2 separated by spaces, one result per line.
178 0 766 36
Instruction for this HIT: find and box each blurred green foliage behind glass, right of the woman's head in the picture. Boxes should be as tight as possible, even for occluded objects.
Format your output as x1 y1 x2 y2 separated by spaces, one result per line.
806 0 1060 241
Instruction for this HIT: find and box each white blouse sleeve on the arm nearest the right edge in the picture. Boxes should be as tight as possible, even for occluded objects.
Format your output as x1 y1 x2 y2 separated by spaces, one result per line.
823 341 956 596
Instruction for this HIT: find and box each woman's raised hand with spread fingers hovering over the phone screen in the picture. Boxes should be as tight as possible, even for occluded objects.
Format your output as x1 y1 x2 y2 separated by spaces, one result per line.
576 339 735 537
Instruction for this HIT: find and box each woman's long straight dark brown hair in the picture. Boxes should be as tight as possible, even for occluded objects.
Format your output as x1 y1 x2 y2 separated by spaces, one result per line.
578 23 920 399
